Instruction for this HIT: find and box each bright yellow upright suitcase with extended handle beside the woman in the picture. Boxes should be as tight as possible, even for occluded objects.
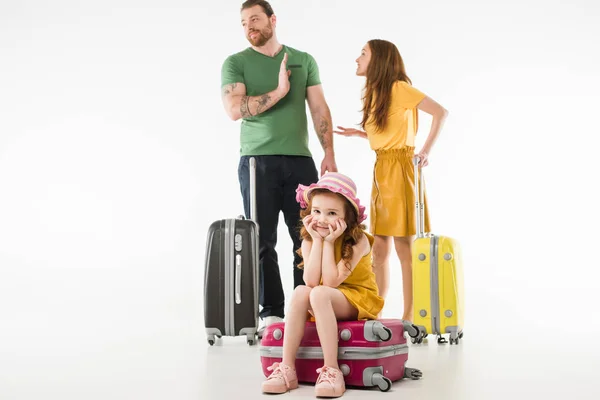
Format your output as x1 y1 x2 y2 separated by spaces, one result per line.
411 157 464 345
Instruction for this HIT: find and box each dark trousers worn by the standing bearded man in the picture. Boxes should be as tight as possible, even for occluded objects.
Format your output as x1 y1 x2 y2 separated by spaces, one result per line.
238 155 319 318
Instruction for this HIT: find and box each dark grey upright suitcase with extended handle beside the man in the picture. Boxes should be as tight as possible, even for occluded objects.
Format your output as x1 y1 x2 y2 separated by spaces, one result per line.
204 158 258 346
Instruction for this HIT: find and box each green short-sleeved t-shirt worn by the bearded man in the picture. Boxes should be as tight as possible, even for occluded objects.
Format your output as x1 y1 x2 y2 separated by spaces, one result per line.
221 46 321 157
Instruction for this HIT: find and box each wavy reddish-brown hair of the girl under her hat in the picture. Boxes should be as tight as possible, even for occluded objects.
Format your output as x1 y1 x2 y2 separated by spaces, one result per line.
296 189 366 269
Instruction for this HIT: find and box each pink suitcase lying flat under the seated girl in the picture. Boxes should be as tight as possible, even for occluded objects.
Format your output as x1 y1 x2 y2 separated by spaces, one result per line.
260 319 422 392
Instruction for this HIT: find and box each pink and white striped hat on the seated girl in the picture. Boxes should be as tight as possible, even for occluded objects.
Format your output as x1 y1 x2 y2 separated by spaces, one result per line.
296 172 367 224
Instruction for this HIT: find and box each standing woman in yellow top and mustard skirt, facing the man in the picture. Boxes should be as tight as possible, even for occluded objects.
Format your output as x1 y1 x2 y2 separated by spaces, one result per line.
334 39 448 321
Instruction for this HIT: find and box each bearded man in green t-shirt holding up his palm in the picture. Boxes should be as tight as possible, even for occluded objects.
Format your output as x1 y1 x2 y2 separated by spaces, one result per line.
221 0 337 336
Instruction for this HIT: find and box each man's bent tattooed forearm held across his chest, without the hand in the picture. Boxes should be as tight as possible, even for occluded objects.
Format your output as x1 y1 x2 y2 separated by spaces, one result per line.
222 83 282 120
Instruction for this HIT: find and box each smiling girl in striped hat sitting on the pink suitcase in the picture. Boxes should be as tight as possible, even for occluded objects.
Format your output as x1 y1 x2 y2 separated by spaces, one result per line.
262 172 383 397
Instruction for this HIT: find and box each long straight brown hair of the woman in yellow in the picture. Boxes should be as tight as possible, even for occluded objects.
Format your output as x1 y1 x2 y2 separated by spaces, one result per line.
360 39 412 132
